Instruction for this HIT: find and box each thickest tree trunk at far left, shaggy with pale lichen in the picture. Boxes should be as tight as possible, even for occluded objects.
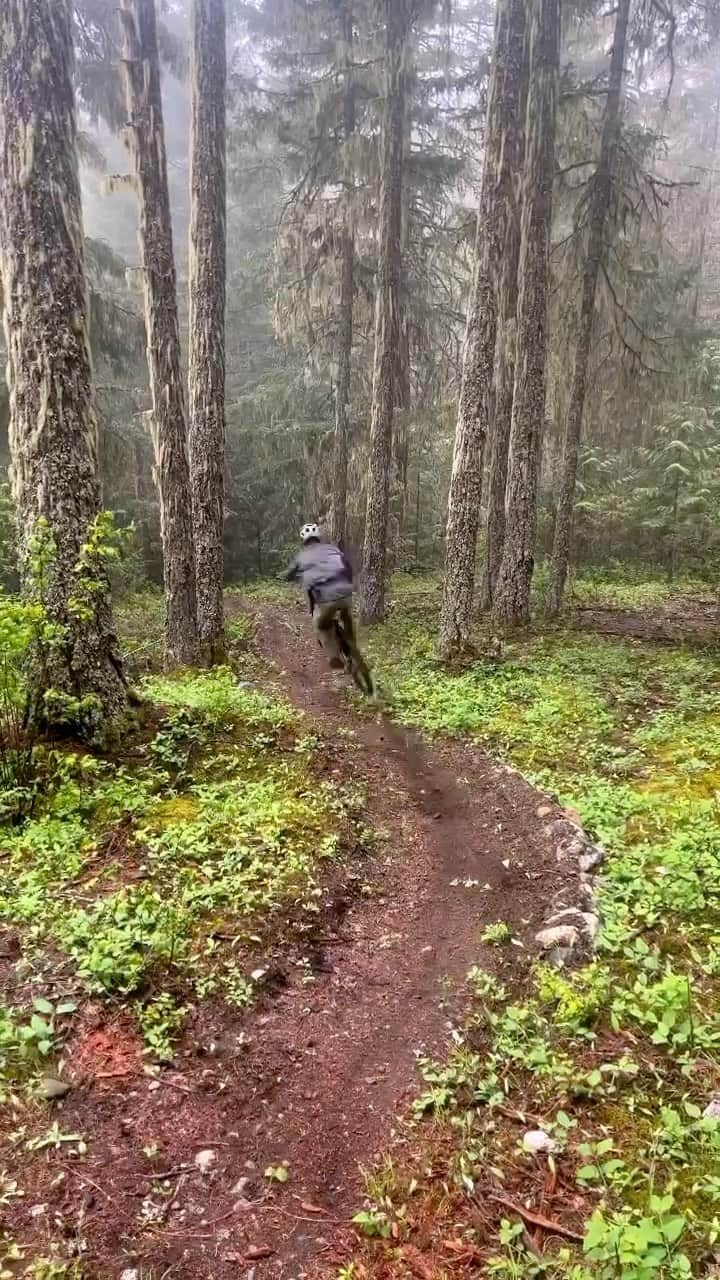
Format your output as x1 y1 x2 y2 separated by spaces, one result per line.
0 0 127 737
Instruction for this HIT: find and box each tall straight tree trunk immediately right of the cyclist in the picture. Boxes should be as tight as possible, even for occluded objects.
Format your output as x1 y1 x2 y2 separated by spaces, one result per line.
360 0 409 622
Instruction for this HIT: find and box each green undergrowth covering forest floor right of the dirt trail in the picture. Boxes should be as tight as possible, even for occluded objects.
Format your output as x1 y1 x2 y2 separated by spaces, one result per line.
342 579 720 1280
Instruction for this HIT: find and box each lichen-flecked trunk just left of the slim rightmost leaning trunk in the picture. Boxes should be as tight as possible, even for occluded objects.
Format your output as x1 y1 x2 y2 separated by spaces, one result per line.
493 0 560 625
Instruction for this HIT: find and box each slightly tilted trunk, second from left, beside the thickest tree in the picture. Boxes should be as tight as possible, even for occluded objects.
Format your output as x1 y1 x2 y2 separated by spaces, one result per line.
119 0 197 666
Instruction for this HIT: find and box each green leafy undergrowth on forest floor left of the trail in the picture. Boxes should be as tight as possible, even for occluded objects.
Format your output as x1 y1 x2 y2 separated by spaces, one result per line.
0 599 361 1223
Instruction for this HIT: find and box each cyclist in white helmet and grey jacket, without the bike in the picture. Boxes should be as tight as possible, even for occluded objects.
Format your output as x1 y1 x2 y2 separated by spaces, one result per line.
283 524 356 671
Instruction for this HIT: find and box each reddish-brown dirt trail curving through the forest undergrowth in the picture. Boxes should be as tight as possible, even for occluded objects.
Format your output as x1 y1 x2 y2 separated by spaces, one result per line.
0 603 570 1280
